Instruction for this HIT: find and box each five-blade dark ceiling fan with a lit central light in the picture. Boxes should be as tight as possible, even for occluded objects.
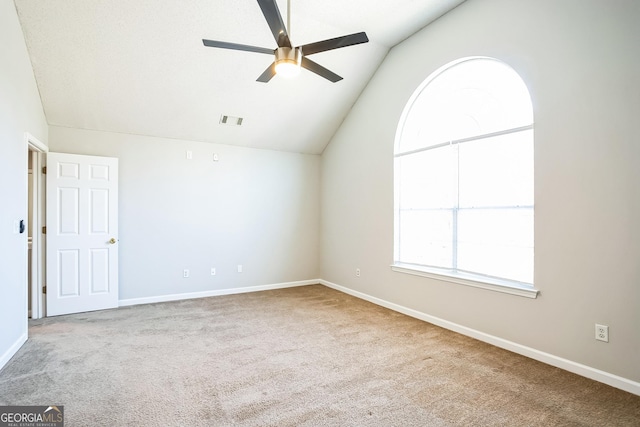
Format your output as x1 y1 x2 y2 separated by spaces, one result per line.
202 0 369 83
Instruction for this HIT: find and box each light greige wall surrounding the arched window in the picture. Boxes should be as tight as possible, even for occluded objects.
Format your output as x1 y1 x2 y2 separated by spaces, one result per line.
321 0 640 392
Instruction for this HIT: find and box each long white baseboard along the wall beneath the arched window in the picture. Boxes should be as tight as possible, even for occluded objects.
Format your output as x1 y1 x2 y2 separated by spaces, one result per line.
319 280 640 396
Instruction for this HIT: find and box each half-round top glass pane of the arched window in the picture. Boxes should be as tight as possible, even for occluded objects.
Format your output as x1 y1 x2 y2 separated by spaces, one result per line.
397 58 533 152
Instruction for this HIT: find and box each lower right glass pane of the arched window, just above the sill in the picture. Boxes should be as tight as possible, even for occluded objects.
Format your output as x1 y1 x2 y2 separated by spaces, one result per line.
458 209 533 283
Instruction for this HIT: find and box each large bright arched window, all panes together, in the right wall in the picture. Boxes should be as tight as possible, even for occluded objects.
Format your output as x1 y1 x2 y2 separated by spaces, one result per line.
394 58 534 289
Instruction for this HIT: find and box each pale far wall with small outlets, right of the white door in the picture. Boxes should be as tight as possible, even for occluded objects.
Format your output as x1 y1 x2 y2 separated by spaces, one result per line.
49 126 320 302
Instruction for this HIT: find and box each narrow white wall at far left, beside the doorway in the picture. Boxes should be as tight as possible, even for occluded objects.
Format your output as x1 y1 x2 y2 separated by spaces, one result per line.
0 1 47 367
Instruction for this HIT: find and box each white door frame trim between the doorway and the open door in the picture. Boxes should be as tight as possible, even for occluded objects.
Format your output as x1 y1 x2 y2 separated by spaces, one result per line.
24 132 49 319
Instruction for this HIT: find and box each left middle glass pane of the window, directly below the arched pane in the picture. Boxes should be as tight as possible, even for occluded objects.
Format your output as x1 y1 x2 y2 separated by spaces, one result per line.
396 146 456 210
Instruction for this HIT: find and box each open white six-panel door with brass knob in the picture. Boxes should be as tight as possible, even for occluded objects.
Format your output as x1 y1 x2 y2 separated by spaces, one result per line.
46 153 118 316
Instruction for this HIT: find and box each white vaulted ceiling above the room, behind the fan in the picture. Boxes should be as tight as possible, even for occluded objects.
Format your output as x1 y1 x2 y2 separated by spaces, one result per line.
15 0 464 154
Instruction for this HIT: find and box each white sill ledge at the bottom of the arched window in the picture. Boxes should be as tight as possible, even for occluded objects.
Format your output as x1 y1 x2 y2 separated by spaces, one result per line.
391 263 540 298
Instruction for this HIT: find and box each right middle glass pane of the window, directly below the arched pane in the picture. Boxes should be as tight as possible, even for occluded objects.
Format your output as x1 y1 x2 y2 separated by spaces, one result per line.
459 130 533 211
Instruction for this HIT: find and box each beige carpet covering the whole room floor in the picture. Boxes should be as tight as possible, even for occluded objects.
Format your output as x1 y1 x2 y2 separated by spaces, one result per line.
0 285 640 426
